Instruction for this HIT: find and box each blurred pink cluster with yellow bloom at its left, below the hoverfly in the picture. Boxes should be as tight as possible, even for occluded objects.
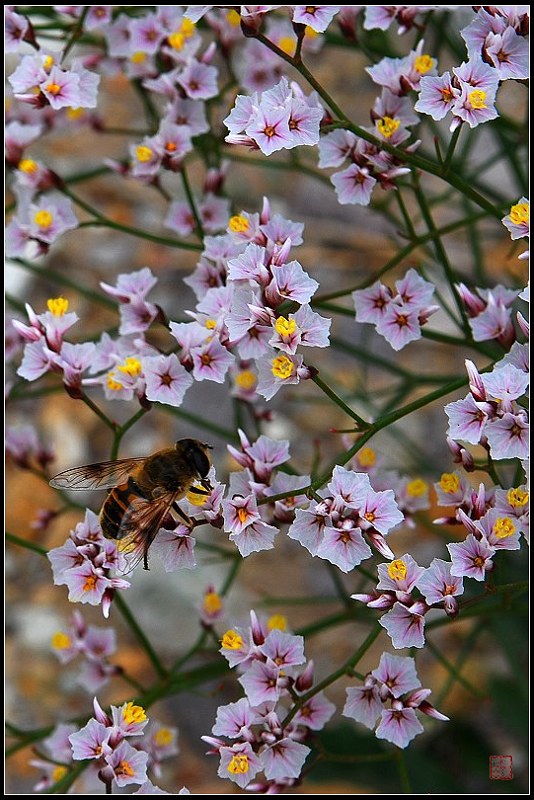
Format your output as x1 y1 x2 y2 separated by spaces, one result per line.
52 611 120 694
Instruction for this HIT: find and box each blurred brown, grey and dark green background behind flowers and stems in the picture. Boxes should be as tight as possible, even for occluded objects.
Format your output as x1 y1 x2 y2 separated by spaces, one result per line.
6 9 527 794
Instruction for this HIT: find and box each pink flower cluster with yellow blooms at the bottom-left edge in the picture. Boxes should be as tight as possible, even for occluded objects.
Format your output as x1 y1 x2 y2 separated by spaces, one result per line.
68 698 178 794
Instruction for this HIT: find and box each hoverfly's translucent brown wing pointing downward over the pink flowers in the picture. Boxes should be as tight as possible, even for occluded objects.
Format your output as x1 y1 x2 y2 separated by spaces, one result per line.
116 484 181 572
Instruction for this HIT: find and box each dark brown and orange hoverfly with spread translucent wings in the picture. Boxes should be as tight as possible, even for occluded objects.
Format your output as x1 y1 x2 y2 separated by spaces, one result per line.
50 439 213 569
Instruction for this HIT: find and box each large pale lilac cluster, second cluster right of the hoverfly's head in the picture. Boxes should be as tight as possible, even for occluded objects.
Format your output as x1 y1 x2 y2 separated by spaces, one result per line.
288 466 404 572
